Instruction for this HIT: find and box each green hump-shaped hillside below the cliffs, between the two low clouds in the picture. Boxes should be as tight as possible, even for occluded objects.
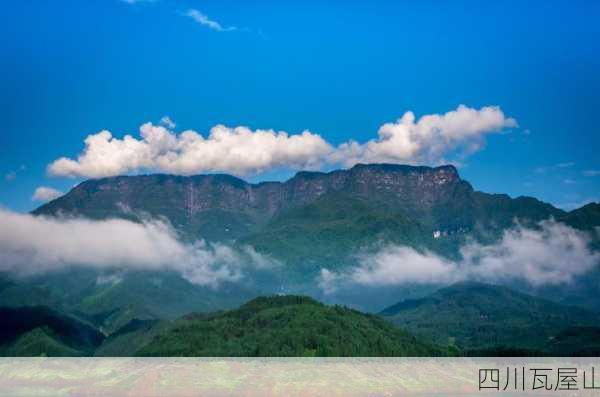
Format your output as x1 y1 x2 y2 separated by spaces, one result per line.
240 193 433 271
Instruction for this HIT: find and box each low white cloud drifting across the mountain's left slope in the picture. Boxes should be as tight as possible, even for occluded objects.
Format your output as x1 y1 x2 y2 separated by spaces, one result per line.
0 209 269 286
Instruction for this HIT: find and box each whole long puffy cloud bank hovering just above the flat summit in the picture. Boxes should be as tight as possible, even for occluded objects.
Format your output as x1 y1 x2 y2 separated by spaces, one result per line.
48 105 517 178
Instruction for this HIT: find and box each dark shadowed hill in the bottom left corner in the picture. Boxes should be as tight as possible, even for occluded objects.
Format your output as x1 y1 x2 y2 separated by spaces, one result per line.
0 306 104 356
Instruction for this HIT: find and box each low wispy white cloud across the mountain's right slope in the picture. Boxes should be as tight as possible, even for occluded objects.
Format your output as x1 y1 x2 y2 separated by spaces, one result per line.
319 220 600 293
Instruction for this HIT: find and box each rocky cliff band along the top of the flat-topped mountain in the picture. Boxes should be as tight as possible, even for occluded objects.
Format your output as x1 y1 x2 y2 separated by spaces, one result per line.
34 164 472 227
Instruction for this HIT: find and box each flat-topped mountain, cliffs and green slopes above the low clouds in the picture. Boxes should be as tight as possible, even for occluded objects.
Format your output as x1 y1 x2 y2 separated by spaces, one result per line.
33 164 567 268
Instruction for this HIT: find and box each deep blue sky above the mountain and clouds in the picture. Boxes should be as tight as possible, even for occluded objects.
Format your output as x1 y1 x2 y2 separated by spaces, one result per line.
0 0 600 211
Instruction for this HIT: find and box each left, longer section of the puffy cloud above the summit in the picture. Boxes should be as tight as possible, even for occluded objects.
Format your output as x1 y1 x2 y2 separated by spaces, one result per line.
48 123 332 178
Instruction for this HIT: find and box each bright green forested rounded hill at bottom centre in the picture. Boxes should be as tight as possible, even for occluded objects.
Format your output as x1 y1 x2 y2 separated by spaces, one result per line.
138 295 443 357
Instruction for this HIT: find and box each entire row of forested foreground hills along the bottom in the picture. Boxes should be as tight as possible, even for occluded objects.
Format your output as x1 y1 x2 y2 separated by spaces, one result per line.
0 283 600 357
